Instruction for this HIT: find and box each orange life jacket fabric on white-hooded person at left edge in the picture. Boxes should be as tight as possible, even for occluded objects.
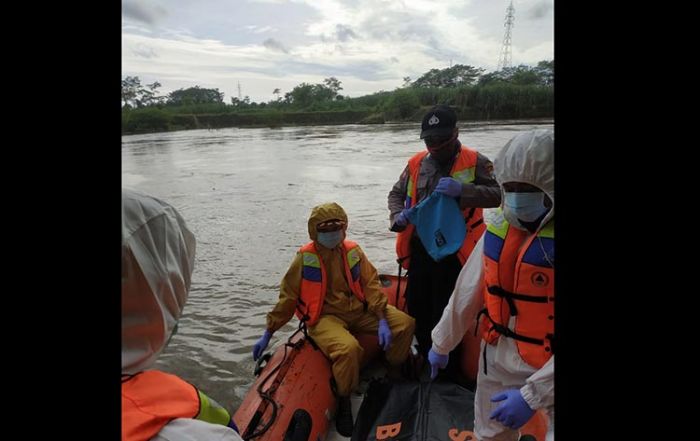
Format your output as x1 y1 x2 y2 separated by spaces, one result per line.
122 370 200 441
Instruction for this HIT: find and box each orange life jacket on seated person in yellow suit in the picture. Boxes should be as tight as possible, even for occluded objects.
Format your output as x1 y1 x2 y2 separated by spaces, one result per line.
296 240 366 326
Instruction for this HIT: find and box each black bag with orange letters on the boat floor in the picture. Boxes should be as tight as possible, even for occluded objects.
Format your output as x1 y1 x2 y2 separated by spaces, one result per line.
352 380 476 441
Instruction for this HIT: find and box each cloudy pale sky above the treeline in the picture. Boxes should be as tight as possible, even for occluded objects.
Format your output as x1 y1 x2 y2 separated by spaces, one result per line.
122 0 554 103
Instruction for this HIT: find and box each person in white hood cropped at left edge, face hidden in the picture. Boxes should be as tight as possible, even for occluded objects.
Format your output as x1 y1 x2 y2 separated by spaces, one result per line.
122 189 242 441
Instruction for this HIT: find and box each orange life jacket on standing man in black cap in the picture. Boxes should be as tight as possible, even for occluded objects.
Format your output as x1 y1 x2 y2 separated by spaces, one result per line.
396 145 486 269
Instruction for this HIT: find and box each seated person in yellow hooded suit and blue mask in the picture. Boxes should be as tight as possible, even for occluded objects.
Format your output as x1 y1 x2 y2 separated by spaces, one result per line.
253 202 415 437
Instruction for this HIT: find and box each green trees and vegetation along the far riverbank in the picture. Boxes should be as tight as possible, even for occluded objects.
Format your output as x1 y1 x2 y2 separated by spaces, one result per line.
122 61 554 134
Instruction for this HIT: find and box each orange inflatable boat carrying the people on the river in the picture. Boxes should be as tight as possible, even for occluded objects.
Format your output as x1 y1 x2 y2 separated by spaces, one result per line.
233 275 547 441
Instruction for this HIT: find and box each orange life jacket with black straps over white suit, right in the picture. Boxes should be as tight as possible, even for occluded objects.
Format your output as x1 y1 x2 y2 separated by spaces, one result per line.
480 213 554 369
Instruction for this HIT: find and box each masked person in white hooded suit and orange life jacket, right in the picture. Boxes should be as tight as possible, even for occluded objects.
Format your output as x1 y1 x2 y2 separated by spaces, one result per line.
428 130 554 441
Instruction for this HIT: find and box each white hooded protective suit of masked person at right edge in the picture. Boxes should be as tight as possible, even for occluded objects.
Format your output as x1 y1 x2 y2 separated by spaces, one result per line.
432 130 554 441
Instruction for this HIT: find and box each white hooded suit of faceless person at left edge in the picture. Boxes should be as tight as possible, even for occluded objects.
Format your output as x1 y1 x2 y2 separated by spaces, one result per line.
122 189 242 441
